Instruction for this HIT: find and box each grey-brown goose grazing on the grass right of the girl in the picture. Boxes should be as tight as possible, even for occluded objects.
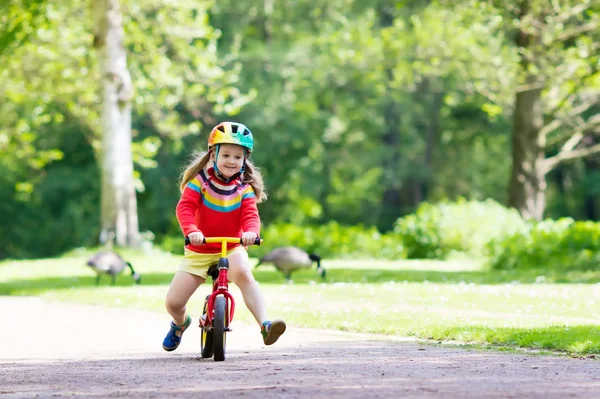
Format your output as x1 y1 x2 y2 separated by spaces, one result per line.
255 247 325 281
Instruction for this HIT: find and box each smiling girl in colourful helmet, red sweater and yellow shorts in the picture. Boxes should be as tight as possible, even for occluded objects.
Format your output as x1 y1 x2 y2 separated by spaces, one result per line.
163 122 285 351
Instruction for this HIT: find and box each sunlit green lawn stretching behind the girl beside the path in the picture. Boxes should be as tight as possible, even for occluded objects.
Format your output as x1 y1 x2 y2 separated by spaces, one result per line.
0 251 600 355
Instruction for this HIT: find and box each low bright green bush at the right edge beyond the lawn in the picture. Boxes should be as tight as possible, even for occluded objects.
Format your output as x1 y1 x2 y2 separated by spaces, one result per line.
488 218 600 271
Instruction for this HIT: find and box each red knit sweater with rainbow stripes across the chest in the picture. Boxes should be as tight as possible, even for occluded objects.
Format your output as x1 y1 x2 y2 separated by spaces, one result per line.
176 167 260 253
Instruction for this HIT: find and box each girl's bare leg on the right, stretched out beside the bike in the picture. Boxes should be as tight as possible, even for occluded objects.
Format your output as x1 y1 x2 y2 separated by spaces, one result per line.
228 250 267 326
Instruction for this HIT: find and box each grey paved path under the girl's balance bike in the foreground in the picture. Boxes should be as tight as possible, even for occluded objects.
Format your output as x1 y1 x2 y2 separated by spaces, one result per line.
0 297 600 399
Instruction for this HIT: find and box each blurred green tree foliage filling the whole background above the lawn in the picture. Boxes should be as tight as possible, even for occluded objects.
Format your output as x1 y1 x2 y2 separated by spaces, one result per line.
0 0 600 258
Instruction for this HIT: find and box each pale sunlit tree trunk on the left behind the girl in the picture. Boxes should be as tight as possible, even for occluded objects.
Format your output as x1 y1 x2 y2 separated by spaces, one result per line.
93 0 139 246
